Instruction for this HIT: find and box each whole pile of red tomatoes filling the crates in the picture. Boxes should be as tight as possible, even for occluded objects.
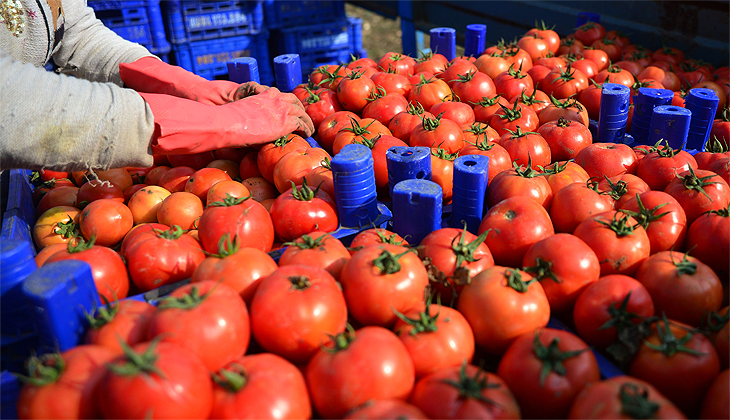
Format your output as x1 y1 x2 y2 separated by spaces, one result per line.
19 18 730 419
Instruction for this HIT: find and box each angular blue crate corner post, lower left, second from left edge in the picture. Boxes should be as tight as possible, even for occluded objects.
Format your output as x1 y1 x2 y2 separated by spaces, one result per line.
23 260 100 352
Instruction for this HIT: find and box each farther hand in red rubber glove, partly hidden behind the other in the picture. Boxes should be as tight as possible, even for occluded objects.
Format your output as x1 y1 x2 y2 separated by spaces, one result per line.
119 57 269 105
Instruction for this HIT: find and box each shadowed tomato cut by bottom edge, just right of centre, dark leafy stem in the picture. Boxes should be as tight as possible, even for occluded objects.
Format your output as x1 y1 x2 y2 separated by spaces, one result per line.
409 363 521 419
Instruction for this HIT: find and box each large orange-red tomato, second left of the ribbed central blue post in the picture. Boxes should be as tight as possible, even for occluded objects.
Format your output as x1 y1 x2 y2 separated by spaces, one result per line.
198 197 274 253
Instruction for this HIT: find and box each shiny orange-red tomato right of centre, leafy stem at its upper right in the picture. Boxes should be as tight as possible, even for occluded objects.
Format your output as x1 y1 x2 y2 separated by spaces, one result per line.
457 266 550 355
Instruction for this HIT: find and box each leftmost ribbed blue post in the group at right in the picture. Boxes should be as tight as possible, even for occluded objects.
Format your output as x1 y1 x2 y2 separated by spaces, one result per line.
596 83 631 143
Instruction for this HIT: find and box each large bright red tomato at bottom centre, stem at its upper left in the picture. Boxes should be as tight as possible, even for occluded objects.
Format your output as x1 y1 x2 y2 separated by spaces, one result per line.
305 326 415 418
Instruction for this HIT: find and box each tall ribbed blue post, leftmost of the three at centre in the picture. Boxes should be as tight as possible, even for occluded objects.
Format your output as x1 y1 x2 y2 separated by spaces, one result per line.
331 144 378 228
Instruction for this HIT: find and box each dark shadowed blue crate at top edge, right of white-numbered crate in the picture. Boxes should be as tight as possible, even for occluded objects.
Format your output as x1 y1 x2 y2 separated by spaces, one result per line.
264 0 345 29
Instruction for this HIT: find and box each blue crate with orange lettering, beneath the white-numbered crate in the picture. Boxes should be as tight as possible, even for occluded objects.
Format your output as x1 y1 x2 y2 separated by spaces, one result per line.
171 32 274 85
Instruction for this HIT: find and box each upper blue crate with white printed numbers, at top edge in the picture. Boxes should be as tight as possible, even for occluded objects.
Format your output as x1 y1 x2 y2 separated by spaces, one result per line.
163 0 264 43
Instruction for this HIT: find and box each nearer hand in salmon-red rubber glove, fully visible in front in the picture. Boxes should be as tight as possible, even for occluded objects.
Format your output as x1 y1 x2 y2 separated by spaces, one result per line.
139 88 314 155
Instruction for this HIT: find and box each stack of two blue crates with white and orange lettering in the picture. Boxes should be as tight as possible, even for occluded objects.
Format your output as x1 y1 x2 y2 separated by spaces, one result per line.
163 0 274 84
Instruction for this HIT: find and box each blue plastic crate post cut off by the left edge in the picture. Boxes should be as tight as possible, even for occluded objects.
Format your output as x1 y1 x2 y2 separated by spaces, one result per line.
0 238 38 344
